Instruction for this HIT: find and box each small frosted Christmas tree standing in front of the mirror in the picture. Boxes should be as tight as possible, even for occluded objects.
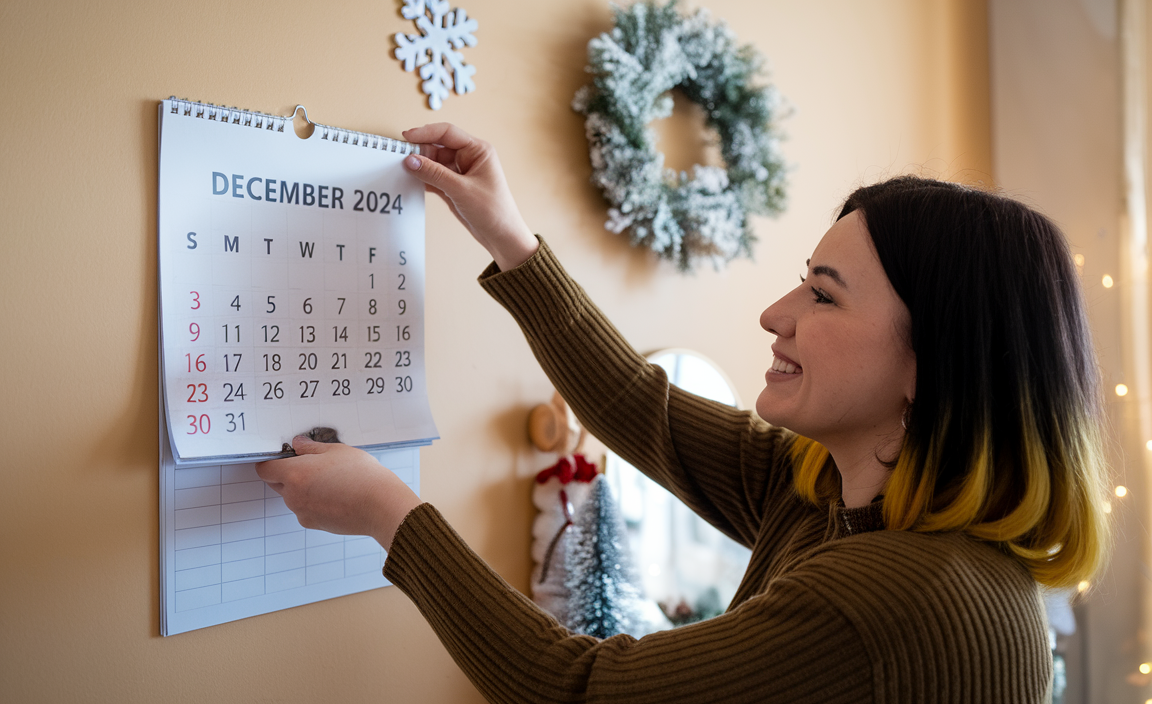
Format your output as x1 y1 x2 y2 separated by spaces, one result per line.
564 475 654 638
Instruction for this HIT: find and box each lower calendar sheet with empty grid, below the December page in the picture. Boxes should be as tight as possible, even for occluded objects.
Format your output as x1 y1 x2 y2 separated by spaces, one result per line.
160 405 420 636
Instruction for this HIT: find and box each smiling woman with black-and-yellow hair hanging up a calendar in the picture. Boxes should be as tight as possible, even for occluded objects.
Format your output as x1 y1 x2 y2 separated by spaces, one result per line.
259 124 1108 703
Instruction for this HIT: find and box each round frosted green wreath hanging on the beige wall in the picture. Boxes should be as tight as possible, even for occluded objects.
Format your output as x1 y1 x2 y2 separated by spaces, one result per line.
573 0 786 271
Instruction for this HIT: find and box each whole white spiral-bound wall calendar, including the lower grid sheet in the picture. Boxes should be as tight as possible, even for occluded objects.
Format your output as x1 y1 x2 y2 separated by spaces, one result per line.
158 99 437 635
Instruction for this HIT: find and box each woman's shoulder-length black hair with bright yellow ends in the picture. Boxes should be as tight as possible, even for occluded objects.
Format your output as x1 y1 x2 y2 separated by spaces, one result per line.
794 176 1109 585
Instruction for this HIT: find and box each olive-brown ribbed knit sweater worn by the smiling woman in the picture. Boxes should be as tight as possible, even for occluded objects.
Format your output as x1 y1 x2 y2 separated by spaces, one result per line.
384 239 1052 704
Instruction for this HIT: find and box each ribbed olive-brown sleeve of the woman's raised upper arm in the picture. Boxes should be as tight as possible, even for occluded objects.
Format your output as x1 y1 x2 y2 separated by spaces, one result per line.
480 240 791 545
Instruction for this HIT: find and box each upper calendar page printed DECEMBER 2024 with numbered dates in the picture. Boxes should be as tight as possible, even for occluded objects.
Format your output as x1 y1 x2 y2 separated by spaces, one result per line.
159 100 437 465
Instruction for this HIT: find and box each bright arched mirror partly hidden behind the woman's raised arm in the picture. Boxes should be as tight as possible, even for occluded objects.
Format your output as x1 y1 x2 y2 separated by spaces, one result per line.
606 349 751 626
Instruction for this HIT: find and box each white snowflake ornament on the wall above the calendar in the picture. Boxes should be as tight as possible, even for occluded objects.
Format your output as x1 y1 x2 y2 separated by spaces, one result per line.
395 0 479 109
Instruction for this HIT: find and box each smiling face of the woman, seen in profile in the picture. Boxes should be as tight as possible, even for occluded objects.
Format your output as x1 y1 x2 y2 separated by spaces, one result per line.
756 211 916 446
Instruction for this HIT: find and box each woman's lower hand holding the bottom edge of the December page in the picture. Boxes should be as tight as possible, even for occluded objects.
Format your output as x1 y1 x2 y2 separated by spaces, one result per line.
256 436 422 550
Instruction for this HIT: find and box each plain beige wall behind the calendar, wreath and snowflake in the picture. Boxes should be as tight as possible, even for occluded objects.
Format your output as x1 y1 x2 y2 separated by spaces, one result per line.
0 0 991 702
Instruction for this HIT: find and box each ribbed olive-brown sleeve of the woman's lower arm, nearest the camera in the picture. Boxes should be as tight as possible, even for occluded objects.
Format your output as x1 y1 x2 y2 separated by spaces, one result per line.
384 504 872 704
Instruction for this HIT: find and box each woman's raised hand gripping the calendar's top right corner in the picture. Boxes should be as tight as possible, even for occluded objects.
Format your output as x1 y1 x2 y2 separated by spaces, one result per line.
404 122 539 271
